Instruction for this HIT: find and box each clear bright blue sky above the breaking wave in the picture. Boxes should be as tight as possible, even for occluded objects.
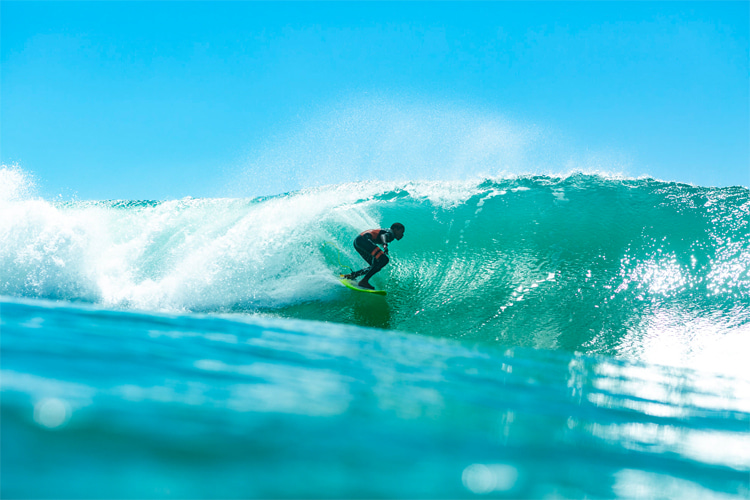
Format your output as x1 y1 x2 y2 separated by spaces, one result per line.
0 0 750 199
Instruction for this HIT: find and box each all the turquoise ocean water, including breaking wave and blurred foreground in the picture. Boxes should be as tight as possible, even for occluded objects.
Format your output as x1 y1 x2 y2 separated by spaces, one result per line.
0 170 750 499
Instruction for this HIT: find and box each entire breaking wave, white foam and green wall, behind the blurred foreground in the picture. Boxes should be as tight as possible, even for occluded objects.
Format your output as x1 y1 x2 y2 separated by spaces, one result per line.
0 174 750 364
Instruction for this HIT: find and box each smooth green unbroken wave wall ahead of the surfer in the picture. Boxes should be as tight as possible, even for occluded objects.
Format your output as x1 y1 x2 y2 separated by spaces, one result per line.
312 176 750 354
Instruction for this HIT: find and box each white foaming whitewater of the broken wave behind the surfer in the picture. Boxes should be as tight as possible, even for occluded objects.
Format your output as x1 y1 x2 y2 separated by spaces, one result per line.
0 183 428 311
